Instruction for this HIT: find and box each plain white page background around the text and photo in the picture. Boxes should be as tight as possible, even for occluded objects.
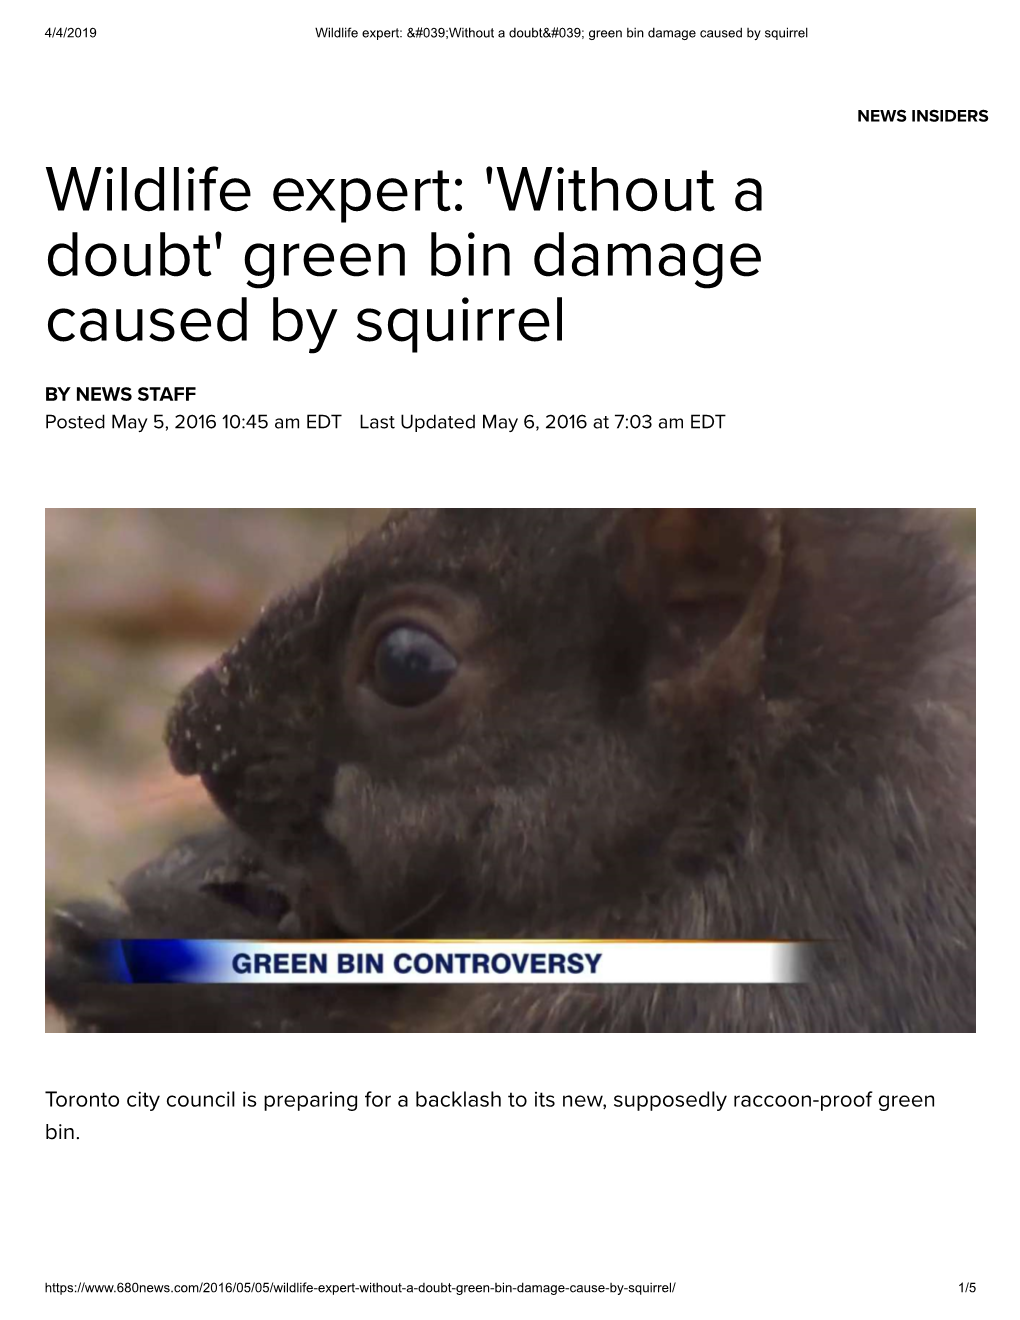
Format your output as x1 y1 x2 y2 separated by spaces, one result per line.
5 3 1016 1316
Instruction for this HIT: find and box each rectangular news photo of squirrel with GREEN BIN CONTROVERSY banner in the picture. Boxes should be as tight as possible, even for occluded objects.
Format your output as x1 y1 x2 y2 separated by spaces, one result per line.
46 508 976 1034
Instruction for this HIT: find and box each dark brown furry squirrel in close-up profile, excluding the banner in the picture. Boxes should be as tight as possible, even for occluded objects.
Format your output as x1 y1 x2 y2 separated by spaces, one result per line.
49 508 975 1032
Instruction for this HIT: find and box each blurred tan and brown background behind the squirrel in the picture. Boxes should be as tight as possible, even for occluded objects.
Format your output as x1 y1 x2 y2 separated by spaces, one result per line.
46 508 975 924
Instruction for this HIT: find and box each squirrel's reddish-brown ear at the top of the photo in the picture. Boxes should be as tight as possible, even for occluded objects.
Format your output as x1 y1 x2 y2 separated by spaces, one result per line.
616 508 782 694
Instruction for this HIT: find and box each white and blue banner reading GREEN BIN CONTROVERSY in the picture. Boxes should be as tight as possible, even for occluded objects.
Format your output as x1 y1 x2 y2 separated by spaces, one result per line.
91 940 815 985
